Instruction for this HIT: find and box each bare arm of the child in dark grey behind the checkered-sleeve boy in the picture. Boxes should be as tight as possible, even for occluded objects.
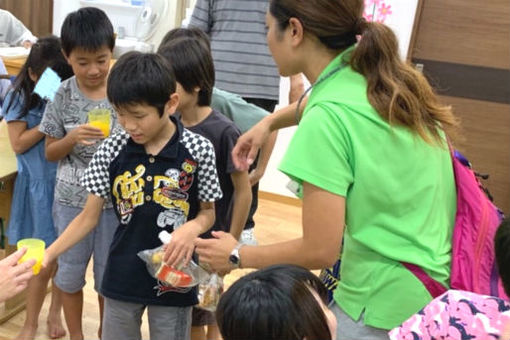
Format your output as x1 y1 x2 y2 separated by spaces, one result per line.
230 171 252 240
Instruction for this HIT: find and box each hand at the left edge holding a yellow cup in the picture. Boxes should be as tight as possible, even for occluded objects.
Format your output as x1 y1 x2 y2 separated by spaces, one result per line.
0 248 36 302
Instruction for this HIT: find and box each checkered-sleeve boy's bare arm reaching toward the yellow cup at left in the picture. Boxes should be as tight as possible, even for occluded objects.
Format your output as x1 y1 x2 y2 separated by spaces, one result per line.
43 194 104 266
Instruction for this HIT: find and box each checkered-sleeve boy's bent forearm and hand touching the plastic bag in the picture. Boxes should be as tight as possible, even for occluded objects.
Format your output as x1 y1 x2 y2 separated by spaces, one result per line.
163 202 216 268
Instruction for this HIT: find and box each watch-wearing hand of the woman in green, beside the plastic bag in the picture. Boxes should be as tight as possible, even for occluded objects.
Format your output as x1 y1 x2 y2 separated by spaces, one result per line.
195 231 237 275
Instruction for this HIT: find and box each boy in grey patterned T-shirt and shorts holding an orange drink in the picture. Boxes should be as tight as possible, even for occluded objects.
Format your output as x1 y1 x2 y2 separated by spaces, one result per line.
39 7 118 340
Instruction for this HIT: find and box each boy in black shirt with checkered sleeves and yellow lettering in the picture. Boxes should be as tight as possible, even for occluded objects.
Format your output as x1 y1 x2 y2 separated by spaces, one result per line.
46 52 222 340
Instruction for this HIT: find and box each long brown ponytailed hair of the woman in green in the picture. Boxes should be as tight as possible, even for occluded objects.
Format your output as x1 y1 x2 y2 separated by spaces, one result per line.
269 0 459 142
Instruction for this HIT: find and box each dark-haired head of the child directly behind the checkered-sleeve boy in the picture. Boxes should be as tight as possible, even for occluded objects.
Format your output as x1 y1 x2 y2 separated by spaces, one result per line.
158 37 214 106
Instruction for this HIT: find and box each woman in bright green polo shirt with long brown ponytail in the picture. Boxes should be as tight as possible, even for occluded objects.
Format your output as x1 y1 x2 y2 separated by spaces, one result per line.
197 0 458 340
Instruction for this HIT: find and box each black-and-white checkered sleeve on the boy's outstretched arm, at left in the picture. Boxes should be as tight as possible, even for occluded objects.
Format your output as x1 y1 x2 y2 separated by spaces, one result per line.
80 131 129 199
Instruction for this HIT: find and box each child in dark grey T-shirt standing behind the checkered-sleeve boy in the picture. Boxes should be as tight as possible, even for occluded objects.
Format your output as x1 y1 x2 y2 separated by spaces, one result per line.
158 37 251 340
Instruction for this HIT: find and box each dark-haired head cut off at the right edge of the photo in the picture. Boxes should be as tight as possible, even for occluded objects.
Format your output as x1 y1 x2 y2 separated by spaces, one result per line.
494 218 510 296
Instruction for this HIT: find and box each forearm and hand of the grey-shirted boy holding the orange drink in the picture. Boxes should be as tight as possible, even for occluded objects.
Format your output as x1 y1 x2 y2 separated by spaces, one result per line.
45 124 104 162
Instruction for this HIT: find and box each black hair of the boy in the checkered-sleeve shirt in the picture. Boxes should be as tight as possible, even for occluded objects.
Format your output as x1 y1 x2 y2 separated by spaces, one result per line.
106 51 175 117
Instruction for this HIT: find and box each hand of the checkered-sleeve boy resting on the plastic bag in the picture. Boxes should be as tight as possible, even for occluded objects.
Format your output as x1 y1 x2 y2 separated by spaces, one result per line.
163 220 201 269
